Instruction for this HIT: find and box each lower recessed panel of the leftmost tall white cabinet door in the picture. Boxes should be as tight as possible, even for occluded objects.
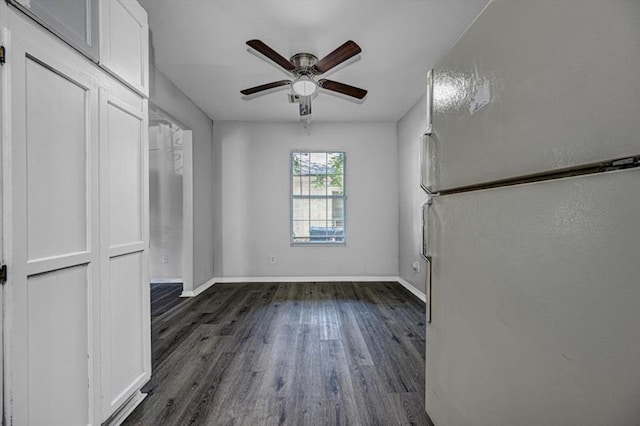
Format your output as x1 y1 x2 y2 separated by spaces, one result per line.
27 265 91 425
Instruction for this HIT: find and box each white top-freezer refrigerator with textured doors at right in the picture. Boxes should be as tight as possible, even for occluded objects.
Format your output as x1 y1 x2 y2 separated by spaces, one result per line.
422 0 640 426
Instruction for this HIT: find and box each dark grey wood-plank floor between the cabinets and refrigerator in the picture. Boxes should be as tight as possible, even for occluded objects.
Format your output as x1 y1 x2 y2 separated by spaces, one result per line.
124 283 430 426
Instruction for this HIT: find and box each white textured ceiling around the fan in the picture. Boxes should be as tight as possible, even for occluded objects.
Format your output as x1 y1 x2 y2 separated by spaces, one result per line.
141 0 487 121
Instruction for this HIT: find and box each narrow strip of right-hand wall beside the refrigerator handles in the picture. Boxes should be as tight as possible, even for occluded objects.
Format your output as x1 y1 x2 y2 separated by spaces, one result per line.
397 96 427 293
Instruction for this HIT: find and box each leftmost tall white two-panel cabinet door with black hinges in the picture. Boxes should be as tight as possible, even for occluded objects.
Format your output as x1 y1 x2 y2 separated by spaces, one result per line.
1 19 99 425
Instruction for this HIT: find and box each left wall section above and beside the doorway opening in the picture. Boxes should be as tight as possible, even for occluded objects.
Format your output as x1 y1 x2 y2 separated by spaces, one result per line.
150 66 219 291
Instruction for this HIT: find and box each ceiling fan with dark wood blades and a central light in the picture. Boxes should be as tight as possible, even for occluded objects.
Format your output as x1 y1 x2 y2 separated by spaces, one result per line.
240 40 367 118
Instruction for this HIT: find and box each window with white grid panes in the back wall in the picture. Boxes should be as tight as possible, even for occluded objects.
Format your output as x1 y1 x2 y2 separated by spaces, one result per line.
291 151 346 245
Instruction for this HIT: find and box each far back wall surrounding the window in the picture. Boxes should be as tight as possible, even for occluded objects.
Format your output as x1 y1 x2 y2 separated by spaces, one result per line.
214 122 398 277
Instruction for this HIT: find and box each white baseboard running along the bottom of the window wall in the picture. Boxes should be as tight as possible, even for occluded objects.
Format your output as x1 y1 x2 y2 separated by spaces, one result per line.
180 276 427 302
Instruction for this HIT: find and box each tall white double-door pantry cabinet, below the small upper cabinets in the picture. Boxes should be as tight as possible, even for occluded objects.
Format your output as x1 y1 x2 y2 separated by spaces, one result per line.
0 3 151 425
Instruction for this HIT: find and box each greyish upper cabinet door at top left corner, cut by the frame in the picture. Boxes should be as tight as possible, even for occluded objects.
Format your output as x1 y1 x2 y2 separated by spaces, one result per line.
9 0 101 62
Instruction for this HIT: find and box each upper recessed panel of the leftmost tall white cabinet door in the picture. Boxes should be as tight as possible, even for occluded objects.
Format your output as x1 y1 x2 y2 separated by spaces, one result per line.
26 58 88 260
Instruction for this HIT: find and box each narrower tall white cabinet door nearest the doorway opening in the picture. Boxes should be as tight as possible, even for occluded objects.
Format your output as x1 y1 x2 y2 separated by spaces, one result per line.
100 90 151 421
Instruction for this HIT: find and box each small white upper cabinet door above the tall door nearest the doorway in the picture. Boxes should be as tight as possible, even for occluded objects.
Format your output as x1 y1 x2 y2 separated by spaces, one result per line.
100 0 149 96
